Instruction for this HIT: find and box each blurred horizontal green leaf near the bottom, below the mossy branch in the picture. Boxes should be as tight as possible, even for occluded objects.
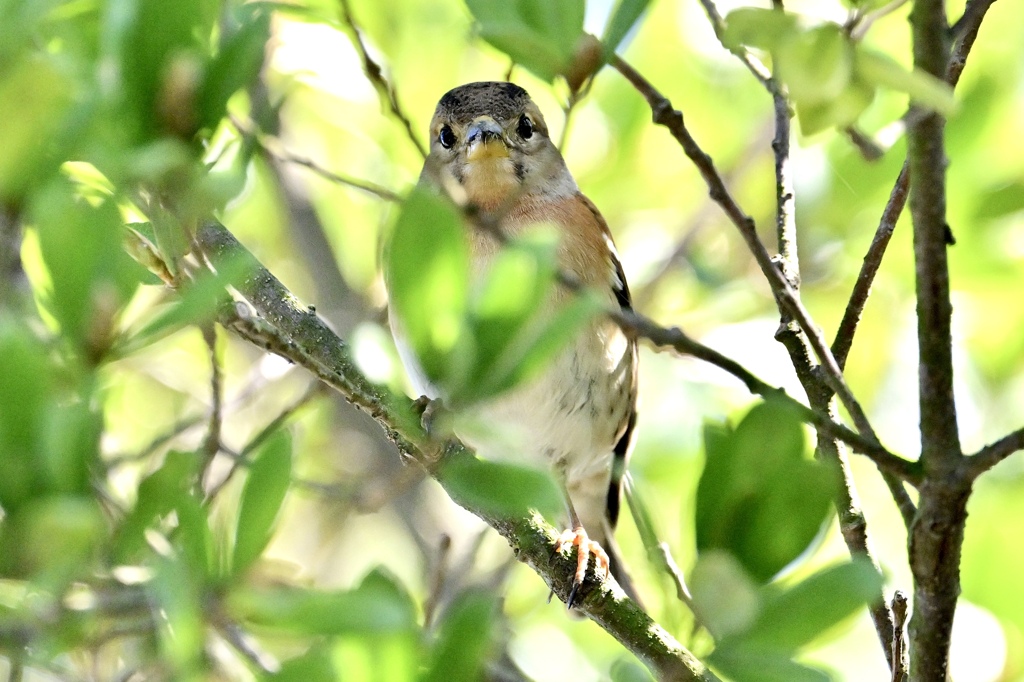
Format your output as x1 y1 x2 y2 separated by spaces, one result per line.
227 571 416 635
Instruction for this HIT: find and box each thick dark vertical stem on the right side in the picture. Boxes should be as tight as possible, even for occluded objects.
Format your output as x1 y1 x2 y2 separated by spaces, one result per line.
907 0 971 671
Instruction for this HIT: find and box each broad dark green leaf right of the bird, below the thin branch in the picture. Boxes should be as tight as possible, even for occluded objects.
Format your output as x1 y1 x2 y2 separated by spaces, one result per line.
696 401 837 582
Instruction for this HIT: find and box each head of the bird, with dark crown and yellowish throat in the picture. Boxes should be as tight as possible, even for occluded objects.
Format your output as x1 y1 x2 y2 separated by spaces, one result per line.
424 82 577 209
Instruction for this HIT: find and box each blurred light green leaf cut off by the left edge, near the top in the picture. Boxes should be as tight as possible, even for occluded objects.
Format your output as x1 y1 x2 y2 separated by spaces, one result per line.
0 53 76 202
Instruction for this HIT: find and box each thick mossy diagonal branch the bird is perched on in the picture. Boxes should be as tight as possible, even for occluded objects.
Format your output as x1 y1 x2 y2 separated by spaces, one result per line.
197 223 717 681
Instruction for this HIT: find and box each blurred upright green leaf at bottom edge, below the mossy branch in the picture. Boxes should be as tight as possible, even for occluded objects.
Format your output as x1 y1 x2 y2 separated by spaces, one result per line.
421 591 499 682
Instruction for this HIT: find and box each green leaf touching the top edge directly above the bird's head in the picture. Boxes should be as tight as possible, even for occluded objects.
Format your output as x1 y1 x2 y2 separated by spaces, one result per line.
466 0 585 81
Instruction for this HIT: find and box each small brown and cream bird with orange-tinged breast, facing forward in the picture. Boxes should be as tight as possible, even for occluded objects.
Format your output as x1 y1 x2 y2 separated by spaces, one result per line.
392 82 637 607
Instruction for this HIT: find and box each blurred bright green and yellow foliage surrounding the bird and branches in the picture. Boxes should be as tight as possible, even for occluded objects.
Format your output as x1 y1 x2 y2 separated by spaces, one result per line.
0 0 1024 680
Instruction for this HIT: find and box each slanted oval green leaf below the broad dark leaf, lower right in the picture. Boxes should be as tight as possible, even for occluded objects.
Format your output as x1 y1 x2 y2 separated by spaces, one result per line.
741 559 882 652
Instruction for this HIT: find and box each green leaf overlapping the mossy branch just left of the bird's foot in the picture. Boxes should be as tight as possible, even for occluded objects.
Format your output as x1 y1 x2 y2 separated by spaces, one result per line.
439 457 563 517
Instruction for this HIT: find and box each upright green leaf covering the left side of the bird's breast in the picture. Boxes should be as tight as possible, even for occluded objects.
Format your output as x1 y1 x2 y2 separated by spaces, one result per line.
386 188 469 385
